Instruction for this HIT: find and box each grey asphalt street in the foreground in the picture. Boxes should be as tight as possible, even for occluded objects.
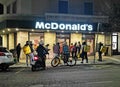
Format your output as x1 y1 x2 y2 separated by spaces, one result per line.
0 64 120 87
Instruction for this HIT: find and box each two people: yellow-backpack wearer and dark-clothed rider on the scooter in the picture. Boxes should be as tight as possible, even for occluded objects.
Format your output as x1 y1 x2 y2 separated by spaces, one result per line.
23 41 48 70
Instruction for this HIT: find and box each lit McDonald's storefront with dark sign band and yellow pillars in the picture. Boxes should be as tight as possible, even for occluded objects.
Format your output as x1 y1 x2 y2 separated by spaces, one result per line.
0 14 111 58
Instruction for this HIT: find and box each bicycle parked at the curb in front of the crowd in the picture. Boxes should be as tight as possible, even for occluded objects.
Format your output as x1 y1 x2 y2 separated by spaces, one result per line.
51 54 77 67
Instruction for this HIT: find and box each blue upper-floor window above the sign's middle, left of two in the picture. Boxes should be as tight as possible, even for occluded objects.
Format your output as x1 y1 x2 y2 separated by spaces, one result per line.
58 0 68 13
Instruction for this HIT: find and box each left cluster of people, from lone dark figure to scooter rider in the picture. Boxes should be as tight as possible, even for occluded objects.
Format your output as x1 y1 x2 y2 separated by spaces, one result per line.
16 41 50 70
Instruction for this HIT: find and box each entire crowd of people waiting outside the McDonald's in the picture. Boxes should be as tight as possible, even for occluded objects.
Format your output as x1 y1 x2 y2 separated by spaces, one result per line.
16 41 103 69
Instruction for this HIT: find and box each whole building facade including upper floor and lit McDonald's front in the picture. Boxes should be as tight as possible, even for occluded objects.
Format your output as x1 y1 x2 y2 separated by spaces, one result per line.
0 0 116 58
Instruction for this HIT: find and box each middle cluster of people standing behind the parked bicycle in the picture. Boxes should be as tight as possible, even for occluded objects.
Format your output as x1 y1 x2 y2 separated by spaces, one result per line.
53 42 88 63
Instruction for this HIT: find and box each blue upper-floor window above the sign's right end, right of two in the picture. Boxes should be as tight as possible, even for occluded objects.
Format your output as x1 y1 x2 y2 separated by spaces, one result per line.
84 2 93 15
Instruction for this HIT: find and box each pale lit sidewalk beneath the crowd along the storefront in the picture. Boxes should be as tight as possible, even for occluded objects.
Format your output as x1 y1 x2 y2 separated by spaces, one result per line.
10 55 120 68
